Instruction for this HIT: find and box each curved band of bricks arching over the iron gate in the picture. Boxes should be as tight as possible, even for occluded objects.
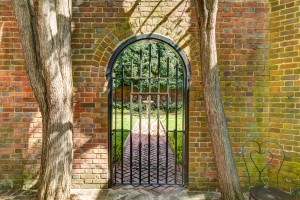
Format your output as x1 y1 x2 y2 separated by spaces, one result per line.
93 22 200 76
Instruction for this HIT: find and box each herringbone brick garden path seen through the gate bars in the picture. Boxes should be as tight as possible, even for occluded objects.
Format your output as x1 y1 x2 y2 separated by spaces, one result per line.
115 119 182 184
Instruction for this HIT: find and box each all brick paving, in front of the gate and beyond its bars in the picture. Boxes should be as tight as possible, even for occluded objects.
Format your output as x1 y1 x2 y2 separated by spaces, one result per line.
0 120 240 200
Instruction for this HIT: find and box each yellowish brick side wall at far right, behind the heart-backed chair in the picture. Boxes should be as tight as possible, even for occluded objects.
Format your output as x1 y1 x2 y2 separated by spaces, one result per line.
269 0 300 190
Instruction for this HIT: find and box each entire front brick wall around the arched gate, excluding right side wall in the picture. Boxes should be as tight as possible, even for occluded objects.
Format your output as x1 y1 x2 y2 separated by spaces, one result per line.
0 0 299 193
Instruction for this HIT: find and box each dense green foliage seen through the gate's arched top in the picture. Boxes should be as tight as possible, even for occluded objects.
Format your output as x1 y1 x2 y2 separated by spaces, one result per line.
114 42 184 90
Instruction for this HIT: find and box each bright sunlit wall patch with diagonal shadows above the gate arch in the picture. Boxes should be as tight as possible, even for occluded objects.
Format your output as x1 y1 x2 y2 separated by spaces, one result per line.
117 0 192 48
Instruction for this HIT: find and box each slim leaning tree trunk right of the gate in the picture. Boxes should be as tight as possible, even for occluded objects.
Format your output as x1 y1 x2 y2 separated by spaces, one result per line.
195 0 243 200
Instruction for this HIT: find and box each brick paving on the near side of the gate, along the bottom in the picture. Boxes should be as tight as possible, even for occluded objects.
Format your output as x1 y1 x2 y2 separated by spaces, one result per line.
0 186 220 200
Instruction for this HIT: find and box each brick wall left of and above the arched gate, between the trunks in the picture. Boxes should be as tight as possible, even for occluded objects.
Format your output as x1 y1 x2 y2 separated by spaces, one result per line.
72 0 197 188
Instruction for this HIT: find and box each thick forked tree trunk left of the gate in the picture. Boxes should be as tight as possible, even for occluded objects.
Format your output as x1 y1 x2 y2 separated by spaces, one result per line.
11 0 73 200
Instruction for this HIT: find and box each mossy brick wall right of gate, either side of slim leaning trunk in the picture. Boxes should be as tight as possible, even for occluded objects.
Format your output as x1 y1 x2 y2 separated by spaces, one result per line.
190 1 269 190
